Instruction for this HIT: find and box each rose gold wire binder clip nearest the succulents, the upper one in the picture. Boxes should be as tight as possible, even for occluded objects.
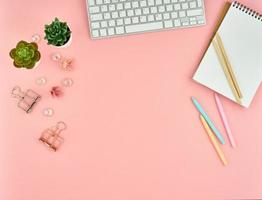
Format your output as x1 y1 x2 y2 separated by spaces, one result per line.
12 86 41 113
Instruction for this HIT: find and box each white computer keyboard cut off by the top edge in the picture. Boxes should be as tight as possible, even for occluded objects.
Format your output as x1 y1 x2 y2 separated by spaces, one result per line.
87 0 205 38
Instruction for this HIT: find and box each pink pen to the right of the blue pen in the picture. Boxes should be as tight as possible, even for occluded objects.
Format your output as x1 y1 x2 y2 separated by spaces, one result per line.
215 93 236 148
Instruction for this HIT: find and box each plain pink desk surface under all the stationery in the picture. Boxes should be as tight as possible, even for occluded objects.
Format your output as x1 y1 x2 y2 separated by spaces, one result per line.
0 0 262 200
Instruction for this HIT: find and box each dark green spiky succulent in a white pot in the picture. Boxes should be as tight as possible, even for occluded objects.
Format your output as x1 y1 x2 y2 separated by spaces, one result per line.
45 18 71 46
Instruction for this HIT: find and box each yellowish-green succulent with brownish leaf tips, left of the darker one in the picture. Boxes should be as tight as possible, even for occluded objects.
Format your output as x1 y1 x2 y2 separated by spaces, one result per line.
9 41 41 69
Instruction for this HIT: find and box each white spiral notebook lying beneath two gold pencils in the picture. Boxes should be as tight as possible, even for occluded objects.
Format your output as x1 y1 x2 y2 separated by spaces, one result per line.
193 2 262 107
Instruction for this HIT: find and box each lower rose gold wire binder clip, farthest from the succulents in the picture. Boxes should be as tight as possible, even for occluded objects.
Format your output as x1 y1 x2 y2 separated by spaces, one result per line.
39 122 67 151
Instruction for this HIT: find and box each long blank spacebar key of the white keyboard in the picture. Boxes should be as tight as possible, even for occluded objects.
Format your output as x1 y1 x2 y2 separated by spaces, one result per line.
125 22 163 33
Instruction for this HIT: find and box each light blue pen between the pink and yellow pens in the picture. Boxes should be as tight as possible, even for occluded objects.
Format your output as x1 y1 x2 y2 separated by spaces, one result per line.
191 97 225 144
